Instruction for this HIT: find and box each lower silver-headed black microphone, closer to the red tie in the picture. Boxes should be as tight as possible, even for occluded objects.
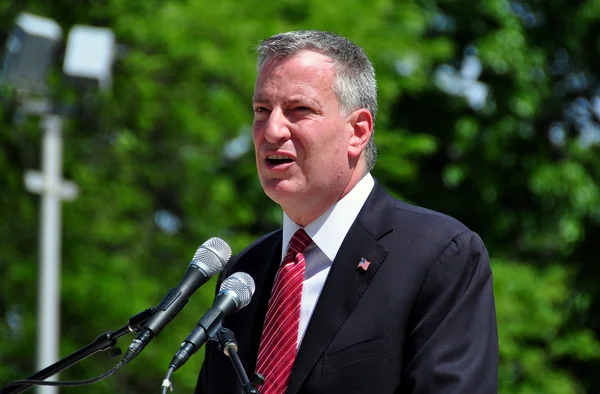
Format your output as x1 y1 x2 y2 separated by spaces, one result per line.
169 272 255 371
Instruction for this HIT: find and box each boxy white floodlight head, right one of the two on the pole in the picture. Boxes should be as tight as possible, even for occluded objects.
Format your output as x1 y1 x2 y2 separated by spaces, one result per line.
63 25 116 89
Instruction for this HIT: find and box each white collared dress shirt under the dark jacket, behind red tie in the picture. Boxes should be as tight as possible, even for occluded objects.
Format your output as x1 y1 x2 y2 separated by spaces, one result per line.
281 174 375 347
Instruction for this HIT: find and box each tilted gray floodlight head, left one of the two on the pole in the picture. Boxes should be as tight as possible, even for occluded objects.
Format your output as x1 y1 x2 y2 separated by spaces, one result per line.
0 13 63 93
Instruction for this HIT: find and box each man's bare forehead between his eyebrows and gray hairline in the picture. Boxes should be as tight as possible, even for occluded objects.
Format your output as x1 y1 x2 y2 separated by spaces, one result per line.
254 51 335 99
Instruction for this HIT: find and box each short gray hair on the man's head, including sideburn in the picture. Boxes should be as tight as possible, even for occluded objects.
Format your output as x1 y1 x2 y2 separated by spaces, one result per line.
257 30 377 171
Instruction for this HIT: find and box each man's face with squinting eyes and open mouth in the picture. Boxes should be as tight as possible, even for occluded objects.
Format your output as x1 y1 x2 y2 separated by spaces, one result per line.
252 51 352 225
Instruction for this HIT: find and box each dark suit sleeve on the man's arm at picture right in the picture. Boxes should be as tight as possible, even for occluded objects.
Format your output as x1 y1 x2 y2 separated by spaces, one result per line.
398 231 498 394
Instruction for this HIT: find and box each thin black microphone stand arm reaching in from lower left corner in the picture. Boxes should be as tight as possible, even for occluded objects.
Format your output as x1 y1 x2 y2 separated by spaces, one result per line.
0 307 154 394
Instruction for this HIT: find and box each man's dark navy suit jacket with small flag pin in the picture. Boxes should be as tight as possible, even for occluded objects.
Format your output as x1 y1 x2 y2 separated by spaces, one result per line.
196 182 498 394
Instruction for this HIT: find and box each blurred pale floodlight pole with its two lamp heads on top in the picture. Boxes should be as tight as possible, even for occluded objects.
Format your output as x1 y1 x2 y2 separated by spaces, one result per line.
0 13 116 394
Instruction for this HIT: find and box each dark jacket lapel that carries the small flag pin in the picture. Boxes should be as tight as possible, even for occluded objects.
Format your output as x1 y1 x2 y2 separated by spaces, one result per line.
286 183 394 394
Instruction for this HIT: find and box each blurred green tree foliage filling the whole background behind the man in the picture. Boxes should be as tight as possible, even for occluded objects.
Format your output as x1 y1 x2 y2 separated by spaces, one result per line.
0 0 600 394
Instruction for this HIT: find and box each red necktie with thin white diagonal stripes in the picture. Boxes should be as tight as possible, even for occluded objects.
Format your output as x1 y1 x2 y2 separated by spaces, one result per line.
256 229 312 394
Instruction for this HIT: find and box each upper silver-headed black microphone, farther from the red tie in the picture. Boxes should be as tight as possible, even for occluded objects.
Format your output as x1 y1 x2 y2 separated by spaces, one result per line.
121 237 231 365
